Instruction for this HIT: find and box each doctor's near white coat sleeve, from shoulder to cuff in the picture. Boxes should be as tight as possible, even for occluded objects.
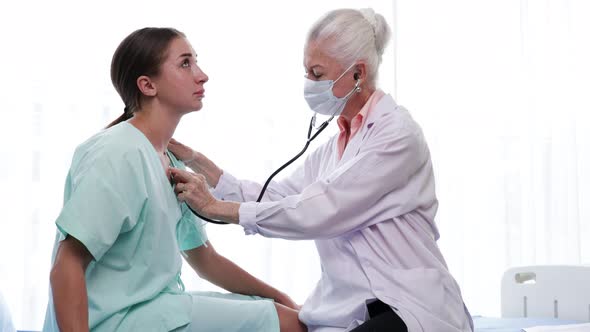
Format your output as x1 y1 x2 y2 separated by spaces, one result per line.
239 128 431 239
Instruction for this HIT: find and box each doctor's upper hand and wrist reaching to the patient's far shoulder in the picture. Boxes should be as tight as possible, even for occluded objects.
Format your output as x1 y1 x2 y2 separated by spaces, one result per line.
168 138 223 187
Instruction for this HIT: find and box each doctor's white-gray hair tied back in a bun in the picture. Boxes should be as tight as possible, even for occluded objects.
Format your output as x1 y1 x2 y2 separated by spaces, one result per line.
305 8 391 86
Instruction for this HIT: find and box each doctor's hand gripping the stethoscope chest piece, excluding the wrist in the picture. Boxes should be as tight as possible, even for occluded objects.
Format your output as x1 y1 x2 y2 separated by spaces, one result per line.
168 168 217 216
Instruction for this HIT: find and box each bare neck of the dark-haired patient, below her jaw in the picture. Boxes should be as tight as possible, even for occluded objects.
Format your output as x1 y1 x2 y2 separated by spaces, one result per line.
129 105 182 154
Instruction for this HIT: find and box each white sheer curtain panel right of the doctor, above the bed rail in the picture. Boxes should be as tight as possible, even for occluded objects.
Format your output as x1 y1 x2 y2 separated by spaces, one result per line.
395 0 590 315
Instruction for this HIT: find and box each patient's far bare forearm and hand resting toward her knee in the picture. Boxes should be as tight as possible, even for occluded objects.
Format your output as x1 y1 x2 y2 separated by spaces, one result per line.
185 241 299 310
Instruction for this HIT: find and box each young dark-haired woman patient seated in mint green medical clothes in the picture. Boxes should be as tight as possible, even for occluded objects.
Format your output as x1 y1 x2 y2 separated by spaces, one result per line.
43 28 305 331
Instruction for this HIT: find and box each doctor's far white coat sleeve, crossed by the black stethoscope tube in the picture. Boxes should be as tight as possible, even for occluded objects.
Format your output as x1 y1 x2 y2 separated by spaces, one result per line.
211 160 309 202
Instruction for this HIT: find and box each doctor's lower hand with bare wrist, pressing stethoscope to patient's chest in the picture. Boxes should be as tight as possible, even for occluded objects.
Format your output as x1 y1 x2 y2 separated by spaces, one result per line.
168 168 240 224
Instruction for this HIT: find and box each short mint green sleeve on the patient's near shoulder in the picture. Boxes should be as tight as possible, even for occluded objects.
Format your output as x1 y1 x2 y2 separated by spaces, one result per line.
55 151 148 261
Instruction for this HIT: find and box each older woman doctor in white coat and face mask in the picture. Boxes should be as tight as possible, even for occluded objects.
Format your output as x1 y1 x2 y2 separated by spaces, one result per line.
169 9 473 332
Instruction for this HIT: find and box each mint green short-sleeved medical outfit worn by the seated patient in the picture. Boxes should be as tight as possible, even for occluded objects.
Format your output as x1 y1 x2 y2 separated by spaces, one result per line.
43 122 279 332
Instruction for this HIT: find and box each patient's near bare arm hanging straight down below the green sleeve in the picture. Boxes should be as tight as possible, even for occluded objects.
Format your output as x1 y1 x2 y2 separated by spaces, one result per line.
50 235 92 332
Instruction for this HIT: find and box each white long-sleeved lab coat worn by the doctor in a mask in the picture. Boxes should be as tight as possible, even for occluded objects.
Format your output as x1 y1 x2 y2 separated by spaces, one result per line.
213 95 473 332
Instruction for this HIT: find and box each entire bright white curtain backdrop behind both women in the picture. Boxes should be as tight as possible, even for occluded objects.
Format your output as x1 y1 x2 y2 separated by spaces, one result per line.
0 0 590 329
